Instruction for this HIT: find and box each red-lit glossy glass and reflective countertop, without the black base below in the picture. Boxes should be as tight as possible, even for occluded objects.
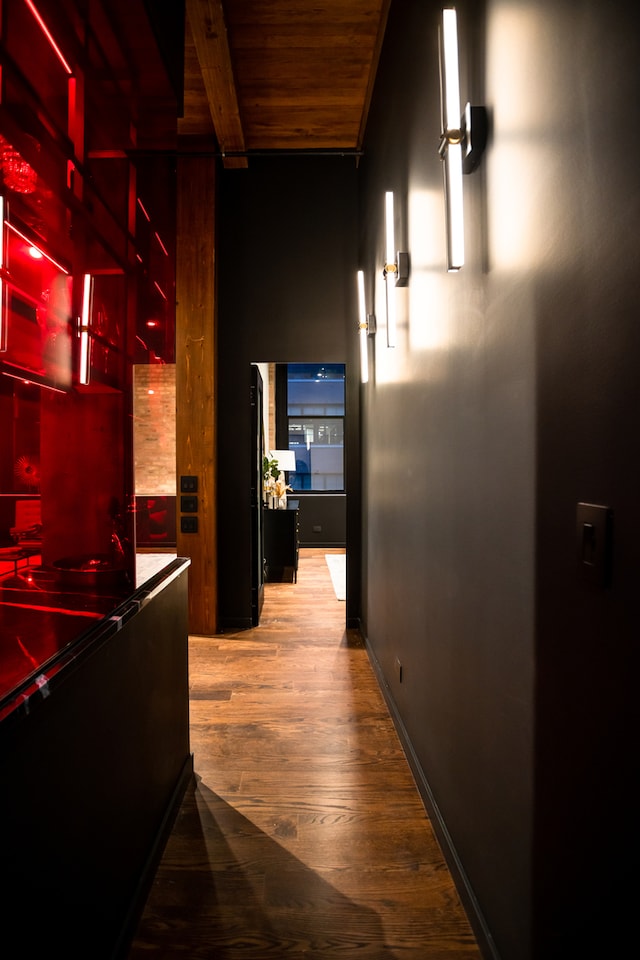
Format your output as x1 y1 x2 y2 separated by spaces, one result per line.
0 0 175 720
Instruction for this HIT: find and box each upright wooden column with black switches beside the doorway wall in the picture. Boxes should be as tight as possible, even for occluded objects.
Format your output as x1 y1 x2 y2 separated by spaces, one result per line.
176 157 218 635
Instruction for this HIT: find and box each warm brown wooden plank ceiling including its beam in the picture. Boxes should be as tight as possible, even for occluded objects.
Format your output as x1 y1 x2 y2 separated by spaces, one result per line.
178 0 391 167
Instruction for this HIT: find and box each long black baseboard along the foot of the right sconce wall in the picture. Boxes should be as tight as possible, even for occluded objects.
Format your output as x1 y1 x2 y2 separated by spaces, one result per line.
359 623 500 960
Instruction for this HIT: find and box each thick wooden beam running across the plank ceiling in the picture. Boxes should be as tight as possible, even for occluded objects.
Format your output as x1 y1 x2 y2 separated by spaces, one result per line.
187 0 249 168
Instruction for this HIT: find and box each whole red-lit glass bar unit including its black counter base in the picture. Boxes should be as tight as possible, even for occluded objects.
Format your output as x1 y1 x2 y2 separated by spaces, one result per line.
0 0 190 960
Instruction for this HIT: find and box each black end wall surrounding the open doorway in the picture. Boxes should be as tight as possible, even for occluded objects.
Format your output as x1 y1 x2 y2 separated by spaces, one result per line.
217 156 360 630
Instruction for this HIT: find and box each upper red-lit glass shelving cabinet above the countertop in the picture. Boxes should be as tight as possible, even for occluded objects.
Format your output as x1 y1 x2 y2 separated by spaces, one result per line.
0 0 180 582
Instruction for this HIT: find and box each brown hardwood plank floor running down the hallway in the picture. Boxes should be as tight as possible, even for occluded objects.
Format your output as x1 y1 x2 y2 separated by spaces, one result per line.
129 549 481 960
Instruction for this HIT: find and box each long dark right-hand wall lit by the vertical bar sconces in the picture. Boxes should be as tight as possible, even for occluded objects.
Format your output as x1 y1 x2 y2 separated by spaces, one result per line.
359 0 640 960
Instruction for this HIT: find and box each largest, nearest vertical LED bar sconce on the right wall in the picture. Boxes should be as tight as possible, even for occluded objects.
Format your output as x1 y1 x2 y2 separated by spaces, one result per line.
438 7 487 272
